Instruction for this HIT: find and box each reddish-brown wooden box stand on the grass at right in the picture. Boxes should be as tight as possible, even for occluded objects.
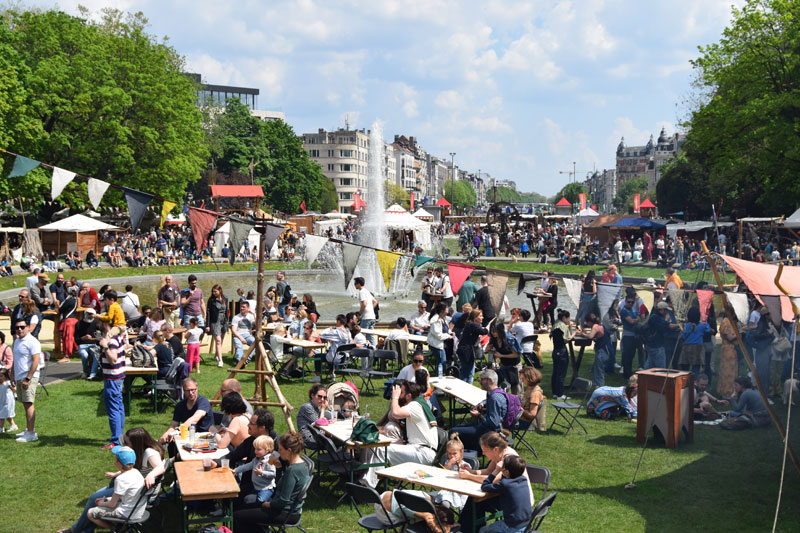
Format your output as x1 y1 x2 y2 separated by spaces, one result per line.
636 368 694 448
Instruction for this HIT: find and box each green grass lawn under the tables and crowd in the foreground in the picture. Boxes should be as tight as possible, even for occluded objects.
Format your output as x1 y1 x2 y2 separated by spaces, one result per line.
0 352 800 532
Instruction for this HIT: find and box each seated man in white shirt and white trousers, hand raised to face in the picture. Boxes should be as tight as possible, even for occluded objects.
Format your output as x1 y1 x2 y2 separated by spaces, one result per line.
364 380 439 487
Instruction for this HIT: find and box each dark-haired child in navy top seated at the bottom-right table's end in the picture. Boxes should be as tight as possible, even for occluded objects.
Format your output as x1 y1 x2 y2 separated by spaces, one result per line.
480 455 533 533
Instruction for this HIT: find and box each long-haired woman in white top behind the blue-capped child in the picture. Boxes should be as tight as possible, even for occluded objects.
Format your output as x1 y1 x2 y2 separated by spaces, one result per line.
58 428 165 533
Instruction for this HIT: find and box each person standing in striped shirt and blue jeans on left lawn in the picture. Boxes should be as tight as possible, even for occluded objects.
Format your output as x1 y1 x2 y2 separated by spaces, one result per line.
99 322 126 450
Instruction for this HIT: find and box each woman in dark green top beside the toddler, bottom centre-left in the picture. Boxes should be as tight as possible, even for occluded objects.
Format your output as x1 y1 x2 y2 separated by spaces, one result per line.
233 432 310 531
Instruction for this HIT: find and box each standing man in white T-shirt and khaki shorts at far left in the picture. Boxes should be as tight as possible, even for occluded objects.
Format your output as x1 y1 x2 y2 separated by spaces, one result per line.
12 320 44 442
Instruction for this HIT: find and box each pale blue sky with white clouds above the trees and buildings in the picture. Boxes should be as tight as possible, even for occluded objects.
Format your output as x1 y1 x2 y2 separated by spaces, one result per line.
34 0 743 196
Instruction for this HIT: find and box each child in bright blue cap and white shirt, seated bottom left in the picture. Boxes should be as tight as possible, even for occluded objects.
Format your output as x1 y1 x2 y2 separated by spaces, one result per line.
89 446 147 531
